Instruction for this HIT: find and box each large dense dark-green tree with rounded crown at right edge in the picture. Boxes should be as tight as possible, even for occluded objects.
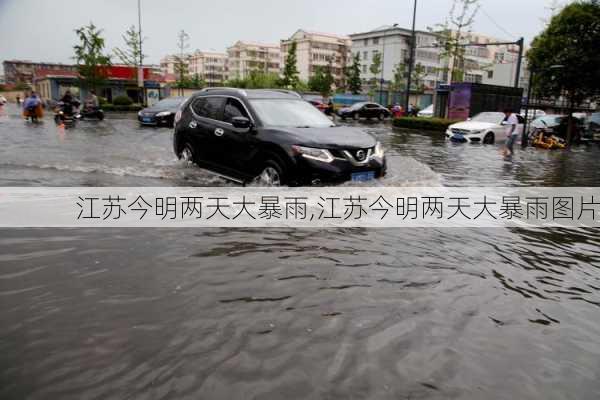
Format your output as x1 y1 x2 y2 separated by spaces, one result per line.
527 1 600 143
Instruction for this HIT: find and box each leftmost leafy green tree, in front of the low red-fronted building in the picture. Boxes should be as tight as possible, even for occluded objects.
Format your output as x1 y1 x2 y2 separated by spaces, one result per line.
73 22 110 90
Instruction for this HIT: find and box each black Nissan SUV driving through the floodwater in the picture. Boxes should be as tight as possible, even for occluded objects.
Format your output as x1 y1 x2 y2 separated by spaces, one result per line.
173 88 386 186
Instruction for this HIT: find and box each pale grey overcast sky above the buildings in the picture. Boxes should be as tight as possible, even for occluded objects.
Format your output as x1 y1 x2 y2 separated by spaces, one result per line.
0 0 564 68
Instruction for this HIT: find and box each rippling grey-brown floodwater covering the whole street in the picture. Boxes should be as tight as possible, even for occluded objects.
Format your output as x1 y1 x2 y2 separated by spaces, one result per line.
0 107 600 399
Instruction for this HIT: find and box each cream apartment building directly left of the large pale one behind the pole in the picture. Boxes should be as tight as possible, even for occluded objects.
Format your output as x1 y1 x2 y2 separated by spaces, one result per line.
281 29 352 86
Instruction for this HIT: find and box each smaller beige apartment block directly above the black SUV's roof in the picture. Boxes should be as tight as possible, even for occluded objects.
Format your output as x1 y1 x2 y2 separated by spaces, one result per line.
227 40 281 79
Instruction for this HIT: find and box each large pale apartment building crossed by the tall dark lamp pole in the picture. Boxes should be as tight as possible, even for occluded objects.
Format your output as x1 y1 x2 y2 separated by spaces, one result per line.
350 25 446 90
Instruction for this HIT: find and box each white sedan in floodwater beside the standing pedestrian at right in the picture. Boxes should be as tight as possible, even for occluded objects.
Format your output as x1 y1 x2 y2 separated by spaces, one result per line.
446 112 525 144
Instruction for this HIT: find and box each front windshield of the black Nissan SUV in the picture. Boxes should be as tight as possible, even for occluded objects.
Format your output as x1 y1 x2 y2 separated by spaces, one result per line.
250 99 334 128
